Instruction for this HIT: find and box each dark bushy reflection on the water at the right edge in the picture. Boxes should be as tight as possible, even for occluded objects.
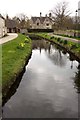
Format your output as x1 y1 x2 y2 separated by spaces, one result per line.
74 64 80 93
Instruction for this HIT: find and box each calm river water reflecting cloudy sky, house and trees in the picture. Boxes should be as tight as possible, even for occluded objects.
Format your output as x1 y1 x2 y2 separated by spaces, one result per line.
3 40 80 118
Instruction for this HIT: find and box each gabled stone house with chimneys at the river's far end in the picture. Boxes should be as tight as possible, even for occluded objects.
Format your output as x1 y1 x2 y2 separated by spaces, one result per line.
30 13 53 29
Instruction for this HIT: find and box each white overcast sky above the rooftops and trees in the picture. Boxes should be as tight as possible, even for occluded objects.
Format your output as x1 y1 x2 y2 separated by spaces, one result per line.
0 0 79 17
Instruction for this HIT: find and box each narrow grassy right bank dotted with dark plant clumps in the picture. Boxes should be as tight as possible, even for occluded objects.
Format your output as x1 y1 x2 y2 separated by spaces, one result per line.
37 33 80 59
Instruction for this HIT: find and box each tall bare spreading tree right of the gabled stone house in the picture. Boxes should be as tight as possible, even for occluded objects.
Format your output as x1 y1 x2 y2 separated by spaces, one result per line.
51 2 71 29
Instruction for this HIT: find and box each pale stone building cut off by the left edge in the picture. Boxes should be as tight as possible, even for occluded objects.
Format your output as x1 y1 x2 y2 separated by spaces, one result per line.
0 14 7 38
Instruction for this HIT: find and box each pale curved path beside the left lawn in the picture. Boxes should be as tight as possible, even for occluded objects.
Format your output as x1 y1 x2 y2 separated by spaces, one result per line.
0 33 18 44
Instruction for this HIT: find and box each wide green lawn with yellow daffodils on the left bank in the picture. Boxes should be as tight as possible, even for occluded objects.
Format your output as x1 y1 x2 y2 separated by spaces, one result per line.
2 34 32 96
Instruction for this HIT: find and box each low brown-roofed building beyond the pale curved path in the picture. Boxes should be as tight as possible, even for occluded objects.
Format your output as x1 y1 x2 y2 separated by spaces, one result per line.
6 16 20 33
